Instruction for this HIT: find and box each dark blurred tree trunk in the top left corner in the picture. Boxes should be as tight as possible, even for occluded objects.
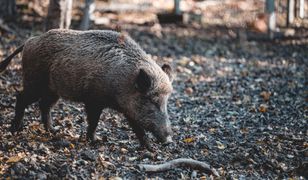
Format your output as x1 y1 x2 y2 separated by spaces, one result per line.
0 0 16 20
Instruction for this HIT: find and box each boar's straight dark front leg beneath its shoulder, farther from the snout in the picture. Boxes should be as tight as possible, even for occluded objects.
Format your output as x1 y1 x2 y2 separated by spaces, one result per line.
85 104 102 142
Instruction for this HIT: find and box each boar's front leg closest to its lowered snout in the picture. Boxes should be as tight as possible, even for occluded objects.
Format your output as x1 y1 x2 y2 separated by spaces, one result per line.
128 120 153 151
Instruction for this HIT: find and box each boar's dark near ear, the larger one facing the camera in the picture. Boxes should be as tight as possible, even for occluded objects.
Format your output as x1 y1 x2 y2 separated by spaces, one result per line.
135 69 152 93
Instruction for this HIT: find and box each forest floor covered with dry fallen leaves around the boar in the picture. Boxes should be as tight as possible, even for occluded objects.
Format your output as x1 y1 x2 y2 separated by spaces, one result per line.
0 0 308 179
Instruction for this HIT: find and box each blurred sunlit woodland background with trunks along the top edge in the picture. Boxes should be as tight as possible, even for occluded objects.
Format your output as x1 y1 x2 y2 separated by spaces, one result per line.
0 0 308 38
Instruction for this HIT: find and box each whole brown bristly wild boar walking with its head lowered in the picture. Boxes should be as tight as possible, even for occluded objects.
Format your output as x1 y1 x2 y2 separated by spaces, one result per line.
0 29 172 146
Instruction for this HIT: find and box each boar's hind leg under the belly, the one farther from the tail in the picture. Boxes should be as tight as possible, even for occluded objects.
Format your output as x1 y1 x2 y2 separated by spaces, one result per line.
39 93 59 131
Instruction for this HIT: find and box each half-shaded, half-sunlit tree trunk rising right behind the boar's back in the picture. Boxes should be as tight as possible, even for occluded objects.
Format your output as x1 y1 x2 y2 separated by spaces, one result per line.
45 0 73 31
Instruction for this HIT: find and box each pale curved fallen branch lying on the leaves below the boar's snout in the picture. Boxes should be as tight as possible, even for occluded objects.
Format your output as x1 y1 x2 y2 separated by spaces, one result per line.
138 158 219 177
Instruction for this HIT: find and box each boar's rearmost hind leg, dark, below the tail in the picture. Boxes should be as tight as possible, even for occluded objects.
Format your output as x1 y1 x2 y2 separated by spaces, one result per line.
10 90 39 133
